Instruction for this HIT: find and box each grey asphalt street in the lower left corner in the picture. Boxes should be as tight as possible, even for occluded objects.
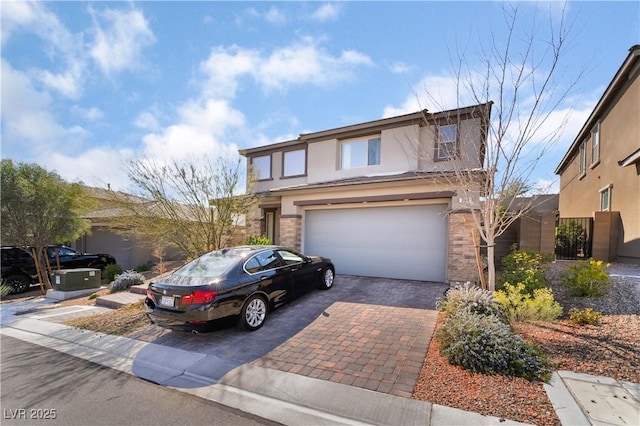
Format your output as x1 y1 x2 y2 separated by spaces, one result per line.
0 336 278 426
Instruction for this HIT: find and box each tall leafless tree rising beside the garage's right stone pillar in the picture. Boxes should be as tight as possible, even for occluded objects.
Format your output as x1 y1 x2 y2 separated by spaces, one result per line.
408 3 584 290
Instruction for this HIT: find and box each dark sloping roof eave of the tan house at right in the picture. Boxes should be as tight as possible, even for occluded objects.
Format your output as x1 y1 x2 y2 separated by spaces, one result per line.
554 44 640 175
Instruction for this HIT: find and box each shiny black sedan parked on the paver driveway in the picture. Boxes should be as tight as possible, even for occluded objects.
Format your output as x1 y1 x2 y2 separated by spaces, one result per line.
145 246 335 331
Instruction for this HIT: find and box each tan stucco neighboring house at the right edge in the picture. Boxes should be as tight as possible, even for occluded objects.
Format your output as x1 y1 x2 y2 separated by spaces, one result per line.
556 45 640 264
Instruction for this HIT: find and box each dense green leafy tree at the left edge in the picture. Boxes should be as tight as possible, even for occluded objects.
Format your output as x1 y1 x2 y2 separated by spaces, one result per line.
2 159 92 294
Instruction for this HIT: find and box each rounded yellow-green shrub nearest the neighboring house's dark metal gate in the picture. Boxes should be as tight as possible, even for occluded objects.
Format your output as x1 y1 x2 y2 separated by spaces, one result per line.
561 259 609 297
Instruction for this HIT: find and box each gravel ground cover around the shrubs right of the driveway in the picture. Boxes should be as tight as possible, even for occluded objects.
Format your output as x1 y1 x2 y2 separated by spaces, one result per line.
413 262 640 425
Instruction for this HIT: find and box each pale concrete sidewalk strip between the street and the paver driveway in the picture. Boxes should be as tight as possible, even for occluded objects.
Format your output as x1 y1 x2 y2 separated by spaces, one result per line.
0 311 522 426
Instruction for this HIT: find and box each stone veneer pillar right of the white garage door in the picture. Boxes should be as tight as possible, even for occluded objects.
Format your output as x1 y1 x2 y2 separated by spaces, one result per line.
447 211 479 284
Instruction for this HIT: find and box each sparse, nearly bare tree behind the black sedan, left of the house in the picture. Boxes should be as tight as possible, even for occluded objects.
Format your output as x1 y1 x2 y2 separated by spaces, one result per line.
112 158 255 258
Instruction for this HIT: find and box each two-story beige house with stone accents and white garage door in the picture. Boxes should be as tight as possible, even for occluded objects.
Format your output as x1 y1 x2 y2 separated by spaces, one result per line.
240 103 491 282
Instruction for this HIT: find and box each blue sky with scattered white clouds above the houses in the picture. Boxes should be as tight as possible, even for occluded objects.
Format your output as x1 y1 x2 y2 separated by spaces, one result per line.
0 1 640 190
